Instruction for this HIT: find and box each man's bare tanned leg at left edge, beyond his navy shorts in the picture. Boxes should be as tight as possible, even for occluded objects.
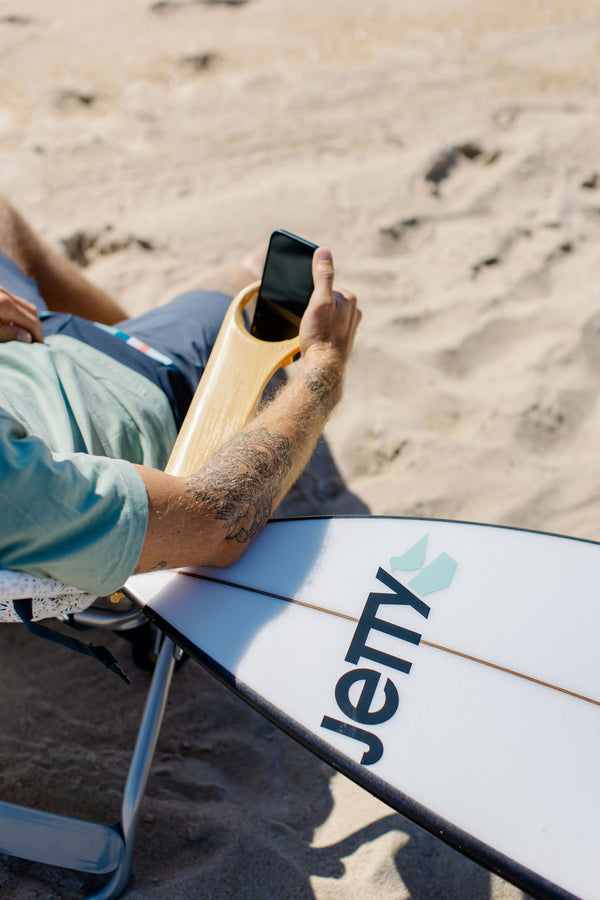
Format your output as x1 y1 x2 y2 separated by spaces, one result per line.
0 195 127 325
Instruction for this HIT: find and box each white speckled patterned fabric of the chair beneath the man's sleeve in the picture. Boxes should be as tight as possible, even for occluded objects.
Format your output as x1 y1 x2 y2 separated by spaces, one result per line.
0 569 97 623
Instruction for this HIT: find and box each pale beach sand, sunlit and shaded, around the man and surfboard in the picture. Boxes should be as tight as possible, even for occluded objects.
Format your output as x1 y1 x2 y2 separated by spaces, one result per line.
0 0 600 900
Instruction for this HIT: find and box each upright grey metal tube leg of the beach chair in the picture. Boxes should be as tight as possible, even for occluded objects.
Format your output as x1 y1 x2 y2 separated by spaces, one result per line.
88 638 180 900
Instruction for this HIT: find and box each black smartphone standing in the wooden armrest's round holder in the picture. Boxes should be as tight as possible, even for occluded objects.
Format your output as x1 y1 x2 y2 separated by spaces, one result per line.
251 231 317 341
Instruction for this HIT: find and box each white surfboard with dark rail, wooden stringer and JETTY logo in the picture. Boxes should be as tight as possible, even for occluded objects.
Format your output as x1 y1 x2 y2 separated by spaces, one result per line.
127 517 600 900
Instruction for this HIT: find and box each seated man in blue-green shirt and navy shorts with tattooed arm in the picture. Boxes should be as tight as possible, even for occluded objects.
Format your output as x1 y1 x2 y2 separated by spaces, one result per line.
0 198 361 594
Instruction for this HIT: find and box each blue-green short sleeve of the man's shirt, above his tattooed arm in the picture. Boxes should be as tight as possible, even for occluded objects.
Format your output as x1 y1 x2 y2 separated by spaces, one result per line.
0 415 148 595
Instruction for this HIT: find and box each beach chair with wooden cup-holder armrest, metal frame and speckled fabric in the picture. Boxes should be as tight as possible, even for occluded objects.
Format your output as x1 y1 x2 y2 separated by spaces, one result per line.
0 283 299 900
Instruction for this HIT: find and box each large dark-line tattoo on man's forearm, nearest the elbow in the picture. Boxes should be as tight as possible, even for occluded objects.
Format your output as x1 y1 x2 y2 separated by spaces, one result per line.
187 427 292 544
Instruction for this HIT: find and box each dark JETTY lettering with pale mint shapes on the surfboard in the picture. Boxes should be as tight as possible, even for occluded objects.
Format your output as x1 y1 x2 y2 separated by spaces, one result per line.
321 534 457 766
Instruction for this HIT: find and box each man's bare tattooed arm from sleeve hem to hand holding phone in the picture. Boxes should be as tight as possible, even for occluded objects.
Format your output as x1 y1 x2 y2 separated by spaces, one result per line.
136 249 361 572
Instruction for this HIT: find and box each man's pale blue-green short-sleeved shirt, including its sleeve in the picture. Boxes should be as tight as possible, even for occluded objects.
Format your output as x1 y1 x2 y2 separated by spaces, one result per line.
0 334 176 594
